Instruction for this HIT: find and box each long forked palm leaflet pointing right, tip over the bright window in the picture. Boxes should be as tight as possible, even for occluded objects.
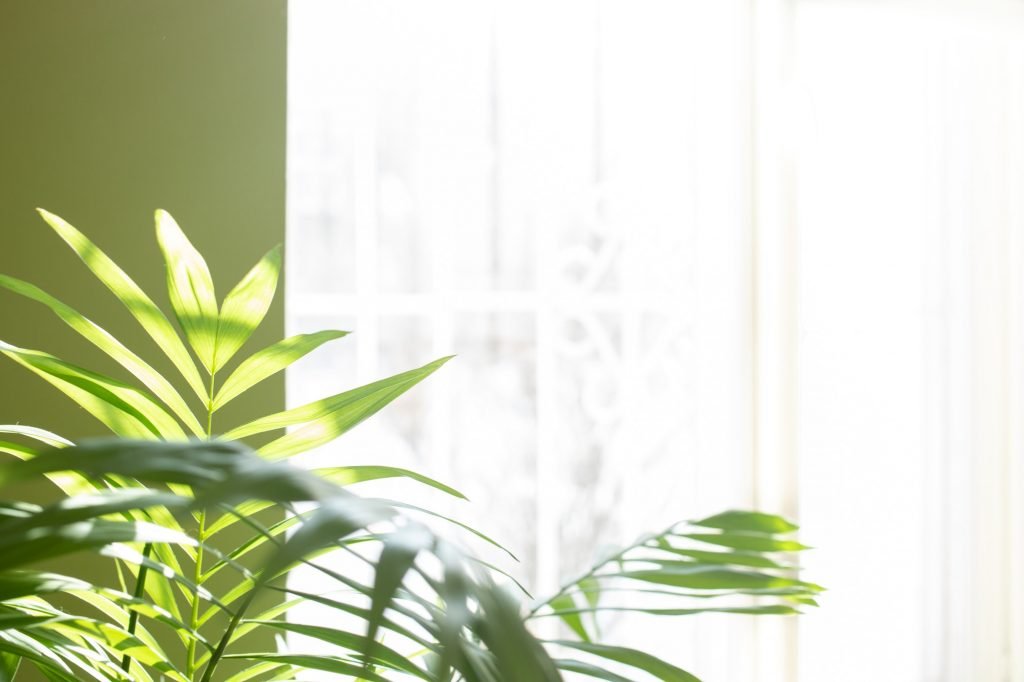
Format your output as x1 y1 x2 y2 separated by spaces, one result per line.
222 357 451 459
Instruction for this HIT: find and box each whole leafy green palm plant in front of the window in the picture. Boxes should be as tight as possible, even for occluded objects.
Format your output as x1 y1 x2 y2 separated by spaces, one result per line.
0 211 820 682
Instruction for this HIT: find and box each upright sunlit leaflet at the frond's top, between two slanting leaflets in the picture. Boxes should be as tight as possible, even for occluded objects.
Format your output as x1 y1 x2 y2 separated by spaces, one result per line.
157 209 220 374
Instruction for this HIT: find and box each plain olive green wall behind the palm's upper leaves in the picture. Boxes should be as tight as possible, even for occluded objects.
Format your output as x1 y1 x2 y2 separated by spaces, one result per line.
0 0 286 438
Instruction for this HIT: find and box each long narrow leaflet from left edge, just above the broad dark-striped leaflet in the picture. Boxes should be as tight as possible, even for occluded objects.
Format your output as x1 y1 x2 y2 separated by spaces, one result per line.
0 274 204 435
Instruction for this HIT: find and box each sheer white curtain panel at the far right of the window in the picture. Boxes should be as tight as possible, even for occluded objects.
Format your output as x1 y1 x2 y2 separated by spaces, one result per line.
795 2 1024 682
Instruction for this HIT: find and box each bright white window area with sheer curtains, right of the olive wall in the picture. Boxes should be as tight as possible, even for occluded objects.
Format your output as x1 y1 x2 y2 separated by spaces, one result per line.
288 0 1024 682
